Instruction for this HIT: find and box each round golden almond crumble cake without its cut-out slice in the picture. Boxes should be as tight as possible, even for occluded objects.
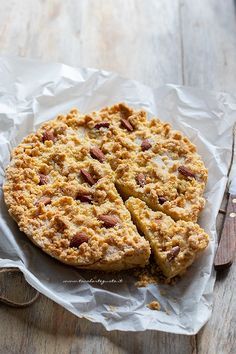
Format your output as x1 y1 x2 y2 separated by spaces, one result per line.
3 104 207 271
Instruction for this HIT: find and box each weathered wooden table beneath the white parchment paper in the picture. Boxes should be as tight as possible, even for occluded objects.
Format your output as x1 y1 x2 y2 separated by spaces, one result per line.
0 0 236 354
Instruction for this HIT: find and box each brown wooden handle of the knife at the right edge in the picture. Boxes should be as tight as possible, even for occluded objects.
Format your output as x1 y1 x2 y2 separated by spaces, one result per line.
214 194 236 270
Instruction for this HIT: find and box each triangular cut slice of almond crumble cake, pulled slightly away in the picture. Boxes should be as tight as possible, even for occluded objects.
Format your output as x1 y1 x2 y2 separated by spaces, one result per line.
125 197 209 278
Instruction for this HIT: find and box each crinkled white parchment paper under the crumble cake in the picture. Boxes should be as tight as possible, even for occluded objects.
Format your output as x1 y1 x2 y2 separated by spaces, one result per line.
0 58 236 334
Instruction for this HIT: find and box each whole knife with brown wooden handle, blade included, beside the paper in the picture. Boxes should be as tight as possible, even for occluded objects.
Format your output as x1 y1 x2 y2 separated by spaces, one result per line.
214 124 236 270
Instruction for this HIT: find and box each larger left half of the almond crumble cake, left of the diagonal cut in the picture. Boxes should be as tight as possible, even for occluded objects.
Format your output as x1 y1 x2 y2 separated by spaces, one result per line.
4 117 150 271
